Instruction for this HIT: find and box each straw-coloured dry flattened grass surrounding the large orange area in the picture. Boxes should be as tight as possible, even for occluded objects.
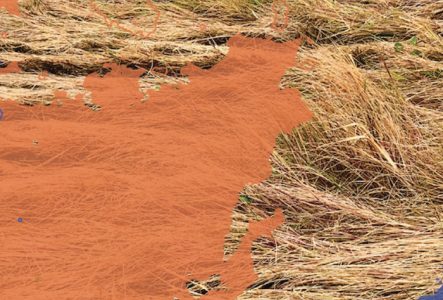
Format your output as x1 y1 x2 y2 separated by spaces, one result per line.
0 0 443 300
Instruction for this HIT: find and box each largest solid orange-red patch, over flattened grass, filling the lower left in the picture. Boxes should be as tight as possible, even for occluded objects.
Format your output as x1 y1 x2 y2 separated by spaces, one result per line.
0 36 311 300
